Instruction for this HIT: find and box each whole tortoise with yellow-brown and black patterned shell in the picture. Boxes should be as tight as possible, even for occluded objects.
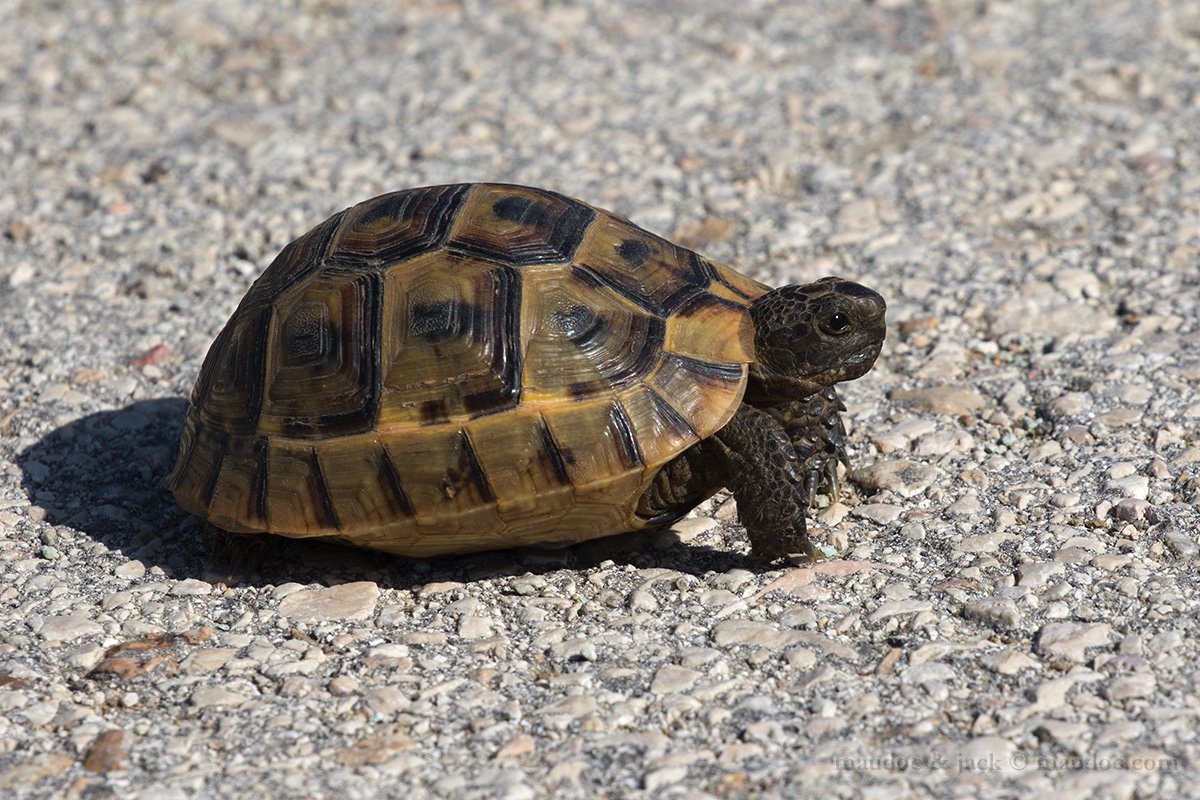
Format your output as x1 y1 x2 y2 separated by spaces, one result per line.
167 184 886 561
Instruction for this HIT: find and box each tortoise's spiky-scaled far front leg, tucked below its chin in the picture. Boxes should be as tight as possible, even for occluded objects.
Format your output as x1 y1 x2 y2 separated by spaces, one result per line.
768 386 850 505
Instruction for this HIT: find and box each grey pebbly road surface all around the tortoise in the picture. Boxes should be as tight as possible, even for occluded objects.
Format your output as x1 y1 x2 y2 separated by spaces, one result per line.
0 0 1200 800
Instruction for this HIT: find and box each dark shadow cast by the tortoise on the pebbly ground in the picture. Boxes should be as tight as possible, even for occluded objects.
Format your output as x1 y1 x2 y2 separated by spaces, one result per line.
17 397 748 589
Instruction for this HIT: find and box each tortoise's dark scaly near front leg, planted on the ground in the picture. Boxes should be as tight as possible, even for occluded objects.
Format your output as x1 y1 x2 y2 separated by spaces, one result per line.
704 403 820 561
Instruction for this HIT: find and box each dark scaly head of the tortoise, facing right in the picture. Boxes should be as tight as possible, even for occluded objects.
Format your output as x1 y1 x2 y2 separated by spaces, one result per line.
746 277 887 404
